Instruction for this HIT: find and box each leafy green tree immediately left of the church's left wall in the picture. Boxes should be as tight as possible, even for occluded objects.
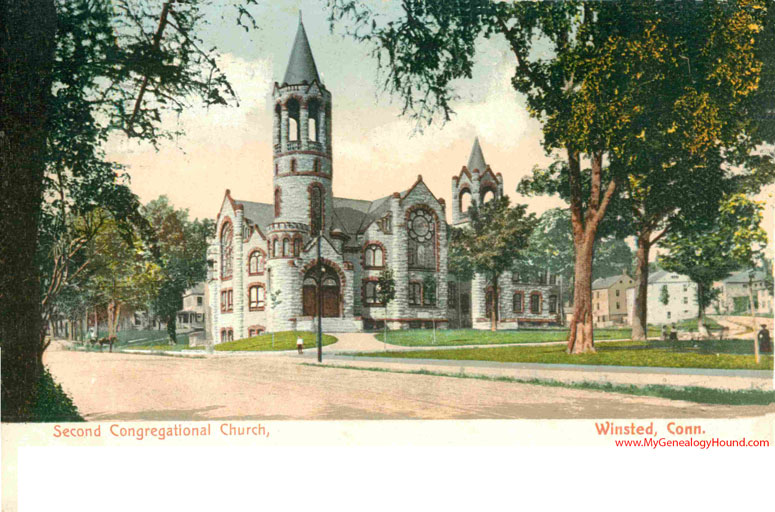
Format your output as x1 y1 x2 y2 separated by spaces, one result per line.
143 196 215 343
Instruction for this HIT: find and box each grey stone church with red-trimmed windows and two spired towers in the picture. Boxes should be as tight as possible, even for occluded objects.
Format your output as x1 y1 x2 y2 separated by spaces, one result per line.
207 20 559 343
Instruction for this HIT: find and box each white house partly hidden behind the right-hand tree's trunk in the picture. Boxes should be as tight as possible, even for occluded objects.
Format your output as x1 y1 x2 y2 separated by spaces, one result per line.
627 270 698 324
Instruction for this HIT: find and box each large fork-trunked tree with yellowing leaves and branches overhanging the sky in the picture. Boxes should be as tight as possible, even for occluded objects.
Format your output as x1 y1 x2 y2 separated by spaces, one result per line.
329 0 767 353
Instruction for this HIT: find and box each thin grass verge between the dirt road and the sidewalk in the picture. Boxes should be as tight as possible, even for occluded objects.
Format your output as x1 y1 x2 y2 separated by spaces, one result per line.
301 363 775 405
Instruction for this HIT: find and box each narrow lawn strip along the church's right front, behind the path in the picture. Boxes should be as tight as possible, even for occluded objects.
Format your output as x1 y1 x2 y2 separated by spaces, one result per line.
376 327 659 347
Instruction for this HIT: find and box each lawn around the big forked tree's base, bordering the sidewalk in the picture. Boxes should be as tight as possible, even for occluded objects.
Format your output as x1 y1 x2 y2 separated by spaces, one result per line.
358 341 772 370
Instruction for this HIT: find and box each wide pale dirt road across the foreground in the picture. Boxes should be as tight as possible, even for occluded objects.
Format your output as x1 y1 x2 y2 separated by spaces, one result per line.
45 346 775 421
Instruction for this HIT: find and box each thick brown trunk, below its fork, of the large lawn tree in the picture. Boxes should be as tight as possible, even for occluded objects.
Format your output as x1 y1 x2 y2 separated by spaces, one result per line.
568 232 595 354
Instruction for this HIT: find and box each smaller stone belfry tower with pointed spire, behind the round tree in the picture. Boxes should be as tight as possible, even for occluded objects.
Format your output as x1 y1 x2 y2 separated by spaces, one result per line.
452 137 503 226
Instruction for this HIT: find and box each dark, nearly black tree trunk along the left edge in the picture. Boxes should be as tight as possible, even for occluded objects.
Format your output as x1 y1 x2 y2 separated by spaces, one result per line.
0 0 56 421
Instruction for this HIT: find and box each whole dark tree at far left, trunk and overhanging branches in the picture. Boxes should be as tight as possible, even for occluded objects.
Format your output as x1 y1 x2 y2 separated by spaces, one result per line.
0 0 256 421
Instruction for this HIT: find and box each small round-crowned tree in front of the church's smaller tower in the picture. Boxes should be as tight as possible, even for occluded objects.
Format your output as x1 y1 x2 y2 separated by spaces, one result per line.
450 196 536 331
